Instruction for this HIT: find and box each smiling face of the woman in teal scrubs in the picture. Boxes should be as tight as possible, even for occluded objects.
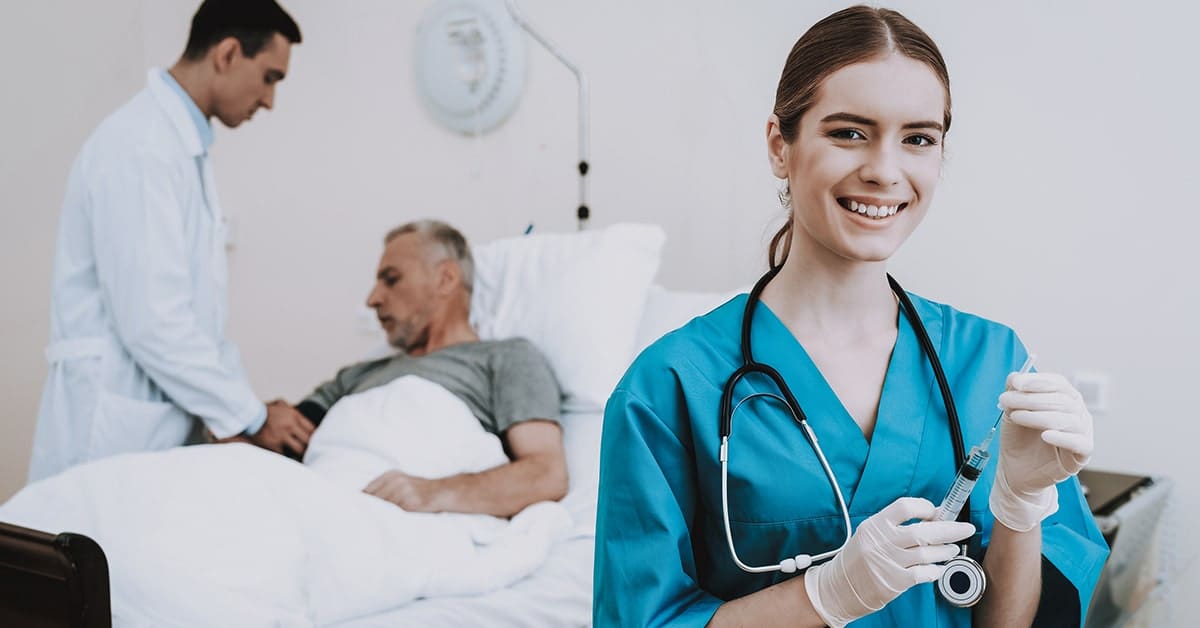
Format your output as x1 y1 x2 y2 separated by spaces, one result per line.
767 52 948 264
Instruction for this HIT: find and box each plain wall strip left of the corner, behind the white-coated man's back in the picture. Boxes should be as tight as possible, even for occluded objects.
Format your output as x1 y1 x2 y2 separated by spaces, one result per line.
0 0 144 501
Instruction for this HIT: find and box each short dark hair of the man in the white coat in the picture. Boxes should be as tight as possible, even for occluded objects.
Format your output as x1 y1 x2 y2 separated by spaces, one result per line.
184 0 300 61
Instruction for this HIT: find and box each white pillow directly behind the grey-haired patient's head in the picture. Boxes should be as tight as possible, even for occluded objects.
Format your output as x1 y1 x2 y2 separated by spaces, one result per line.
470 225 666 412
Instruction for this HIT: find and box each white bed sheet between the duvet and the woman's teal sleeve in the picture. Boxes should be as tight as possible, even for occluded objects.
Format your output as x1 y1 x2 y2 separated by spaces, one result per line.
336 413 604 628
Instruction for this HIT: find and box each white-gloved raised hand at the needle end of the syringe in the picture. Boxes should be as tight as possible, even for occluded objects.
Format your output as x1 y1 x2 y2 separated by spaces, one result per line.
989 373 1092 532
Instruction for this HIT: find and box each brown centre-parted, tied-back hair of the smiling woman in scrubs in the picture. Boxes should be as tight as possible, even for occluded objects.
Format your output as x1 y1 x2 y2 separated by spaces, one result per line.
767 5 950 268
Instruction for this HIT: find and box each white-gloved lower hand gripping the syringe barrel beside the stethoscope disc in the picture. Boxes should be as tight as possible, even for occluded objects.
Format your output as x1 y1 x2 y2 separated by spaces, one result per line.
804 497 974 628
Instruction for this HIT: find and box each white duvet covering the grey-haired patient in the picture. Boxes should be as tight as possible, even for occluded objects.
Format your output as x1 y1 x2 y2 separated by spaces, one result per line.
0 376 570 627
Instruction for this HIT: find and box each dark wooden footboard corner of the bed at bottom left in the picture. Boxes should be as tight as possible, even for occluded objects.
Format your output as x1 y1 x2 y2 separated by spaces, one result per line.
0 522 113 628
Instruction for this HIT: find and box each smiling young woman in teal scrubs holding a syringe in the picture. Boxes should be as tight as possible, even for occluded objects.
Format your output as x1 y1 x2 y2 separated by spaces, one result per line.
594 6 1108 627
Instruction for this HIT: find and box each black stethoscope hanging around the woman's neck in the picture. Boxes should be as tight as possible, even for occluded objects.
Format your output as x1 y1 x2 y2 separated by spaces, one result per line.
720 267 988 606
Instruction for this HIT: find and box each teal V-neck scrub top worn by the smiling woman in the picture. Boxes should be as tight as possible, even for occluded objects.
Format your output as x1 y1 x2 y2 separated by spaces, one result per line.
593 294 1108 628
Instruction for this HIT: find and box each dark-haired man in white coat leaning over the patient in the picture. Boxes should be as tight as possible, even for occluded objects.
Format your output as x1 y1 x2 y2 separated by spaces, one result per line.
29 0 312 482
